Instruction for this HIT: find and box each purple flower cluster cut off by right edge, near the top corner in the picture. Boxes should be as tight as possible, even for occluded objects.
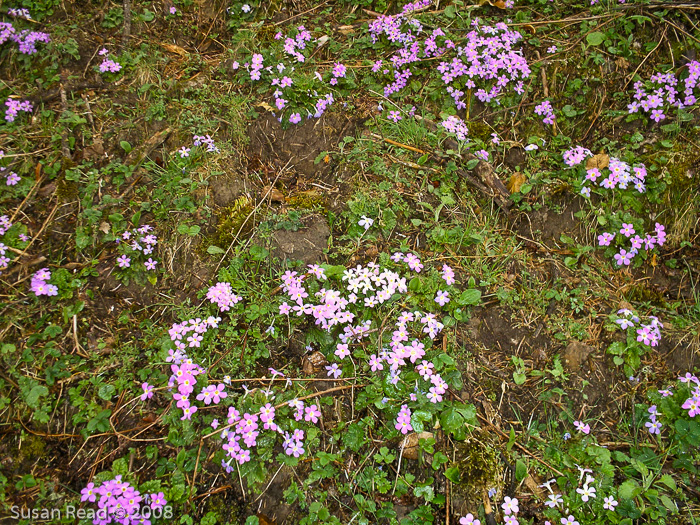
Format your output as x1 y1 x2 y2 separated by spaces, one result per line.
627 60 700 122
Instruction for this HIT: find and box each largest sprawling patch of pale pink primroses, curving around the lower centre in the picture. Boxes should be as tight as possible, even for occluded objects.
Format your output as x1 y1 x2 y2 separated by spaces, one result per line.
146 252 478 471
